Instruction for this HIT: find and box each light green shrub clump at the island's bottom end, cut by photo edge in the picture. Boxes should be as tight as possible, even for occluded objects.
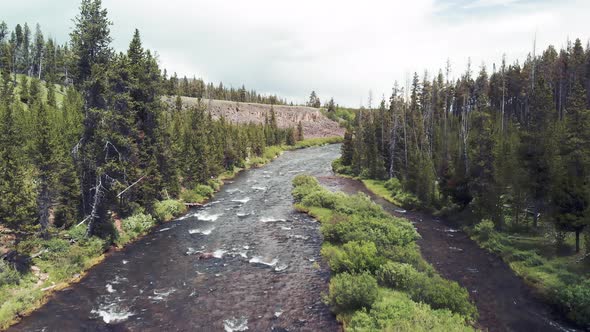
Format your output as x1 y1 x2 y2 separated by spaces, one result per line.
347 291 473 332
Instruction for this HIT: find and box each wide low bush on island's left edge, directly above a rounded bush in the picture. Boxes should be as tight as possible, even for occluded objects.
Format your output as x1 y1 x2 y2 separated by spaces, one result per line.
322 241 383 273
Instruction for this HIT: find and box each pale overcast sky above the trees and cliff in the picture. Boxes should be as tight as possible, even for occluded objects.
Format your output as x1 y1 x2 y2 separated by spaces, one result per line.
0 0 590 107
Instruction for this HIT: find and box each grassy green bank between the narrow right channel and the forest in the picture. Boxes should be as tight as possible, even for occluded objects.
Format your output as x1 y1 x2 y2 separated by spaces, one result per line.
334 167 590 327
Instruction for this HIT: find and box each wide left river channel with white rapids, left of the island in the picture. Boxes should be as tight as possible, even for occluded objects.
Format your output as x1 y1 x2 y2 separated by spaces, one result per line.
10 145 340 331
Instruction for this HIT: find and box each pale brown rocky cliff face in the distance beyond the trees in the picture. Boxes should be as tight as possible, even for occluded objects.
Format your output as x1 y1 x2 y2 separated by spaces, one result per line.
164 97 344 138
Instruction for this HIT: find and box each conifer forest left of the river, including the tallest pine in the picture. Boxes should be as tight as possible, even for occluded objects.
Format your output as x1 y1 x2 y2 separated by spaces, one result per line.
0 0 302 239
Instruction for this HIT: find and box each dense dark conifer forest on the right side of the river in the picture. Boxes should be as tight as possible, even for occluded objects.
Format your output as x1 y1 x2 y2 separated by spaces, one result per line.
340 39 590 250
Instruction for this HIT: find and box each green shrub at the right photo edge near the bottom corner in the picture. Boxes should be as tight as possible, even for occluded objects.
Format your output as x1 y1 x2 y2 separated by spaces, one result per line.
558 279 590 326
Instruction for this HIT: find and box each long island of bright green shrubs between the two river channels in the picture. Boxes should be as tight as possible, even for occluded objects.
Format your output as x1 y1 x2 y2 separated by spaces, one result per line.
293 175 477 331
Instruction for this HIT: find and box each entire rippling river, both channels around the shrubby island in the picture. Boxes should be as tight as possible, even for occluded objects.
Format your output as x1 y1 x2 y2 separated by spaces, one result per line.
10 145 575 332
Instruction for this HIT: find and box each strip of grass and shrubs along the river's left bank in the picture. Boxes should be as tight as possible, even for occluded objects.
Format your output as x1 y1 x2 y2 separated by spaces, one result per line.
0 137 342 330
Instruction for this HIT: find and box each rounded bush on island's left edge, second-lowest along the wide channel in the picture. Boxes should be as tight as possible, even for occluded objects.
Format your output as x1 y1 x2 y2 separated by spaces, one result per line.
327 272 379 313
